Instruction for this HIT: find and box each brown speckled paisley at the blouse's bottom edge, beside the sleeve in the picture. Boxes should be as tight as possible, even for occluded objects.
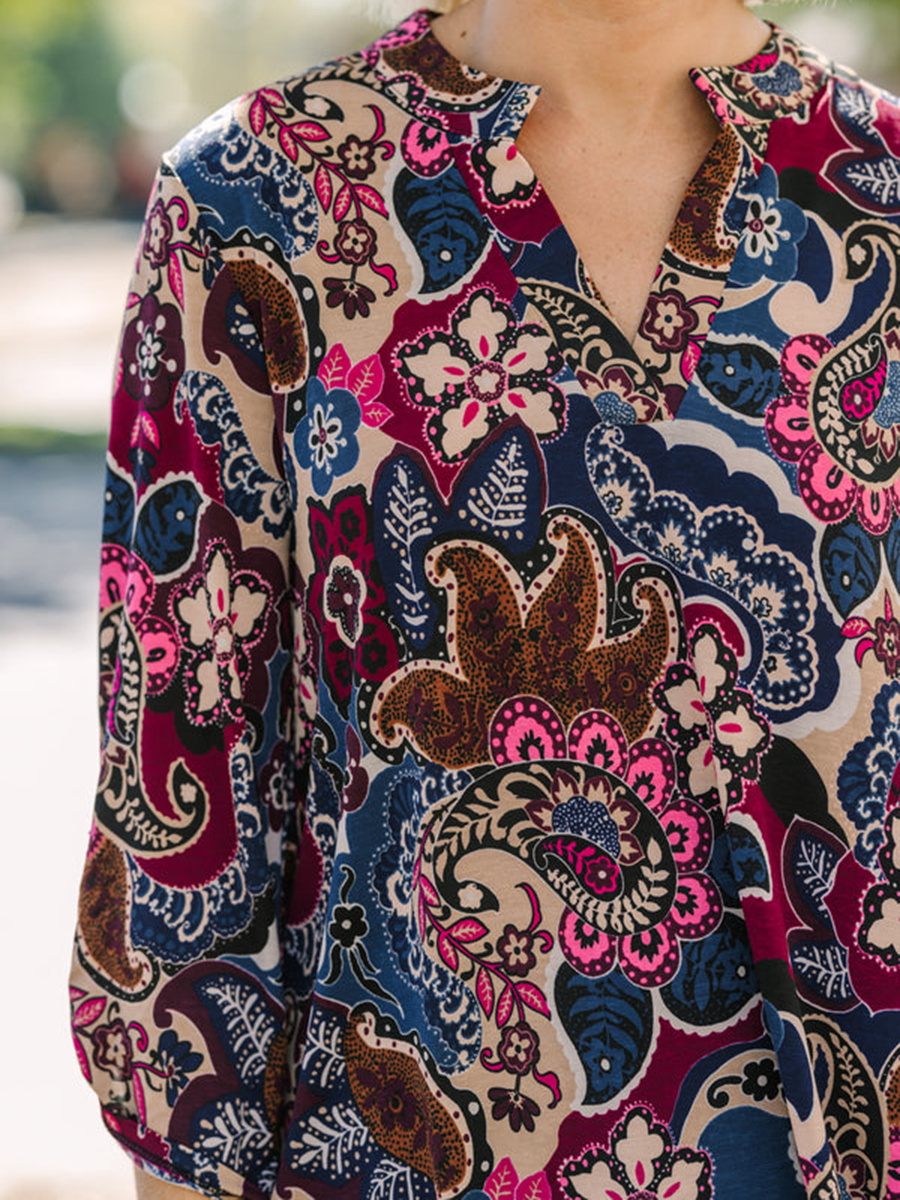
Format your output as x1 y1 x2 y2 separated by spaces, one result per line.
343 1004 480 1198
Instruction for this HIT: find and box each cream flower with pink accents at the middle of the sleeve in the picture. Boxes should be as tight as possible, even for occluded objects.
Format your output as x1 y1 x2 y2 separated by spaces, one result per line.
173 541 271 726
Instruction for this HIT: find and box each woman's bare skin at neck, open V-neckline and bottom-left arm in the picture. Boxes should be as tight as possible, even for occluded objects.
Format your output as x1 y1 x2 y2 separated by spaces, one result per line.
136 0 768 1200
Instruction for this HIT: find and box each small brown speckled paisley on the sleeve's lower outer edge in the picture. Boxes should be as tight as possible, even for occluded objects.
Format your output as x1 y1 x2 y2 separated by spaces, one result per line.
78 832 150 992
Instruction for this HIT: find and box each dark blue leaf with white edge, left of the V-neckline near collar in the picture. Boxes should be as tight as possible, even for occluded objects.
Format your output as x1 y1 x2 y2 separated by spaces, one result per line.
394 167 490 293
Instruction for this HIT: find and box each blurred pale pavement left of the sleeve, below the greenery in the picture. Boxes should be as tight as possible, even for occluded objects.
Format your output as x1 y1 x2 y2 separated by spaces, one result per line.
0 216 136 1200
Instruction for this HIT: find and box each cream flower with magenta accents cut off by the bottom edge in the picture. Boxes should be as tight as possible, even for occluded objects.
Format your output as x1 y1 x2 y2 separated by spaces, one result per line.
559 1104 713 1200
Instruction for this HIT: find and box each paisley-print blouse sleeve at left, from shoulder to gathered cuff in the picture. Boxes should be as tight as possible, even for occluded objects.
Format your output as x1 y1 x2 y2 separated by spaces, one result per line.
70 150 314 1198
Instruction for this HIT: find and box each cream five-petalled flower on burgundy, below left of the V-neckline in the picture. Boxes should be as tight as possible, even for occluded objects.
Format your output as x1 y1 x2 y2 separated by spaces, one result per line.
397 288 565 462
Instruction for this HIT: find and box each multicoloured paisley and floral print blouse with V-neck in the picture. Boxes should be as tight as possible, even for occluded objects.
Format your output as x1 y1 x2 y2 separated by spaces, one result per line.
71 12 900 1200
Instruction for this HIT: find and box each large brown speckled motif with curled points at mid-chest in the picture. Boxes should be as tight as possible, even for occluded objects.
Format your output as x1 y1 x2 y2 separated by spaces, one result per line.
372 512 679 768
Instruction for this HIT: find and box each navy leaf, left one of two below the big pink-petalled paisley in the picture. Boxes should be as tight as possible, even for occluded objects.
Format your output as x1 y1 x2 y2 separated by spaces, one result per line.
556 965 654 1104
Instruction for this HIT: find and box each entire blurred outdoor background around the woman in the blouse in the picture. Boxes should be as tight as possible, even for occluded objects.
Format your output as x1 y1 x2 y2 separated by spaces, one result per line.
0 0 900 1200
